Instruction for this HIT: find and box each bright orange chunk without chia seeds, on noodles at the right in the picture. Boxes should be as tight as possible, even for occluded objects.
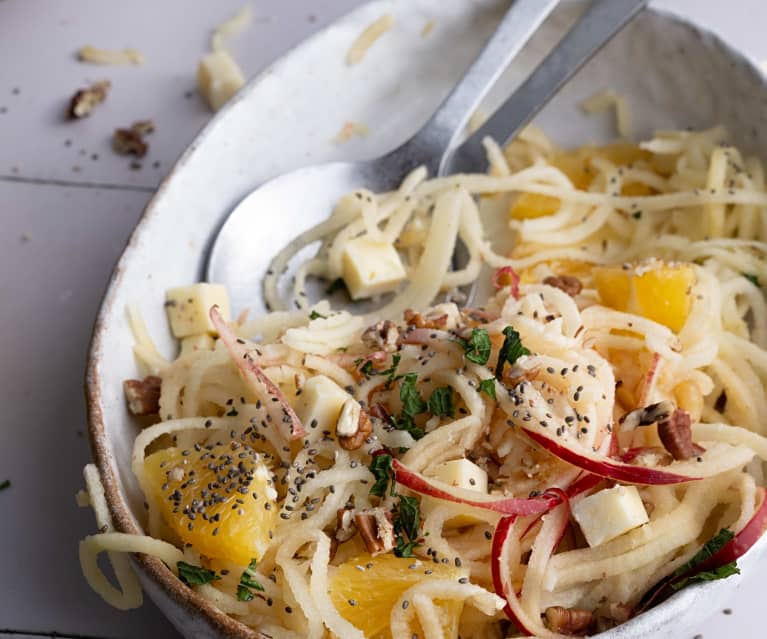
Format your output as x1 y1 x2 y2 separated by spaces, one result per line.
593 260 695 332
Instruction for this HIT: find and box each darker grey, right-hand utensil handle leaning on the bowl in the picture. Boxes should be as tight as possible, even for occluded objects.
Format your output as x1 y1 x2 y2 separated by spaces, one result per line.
448 0 647 173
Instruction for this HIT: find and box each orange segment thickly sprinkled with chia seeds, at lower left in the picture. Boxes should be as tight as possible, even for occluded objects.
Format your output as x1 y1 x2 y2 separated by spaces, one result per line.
145 443 277 566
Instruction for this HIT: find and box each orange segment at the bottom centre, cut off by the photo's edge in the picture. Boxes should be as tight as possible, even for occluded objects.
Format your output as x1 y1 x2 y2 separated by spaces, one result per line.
330 553 468 639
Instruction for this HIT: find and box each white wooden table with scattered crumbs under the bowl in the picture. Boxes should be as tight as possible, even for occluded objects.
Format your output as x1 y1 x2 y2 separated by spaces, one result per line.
0 0 767 639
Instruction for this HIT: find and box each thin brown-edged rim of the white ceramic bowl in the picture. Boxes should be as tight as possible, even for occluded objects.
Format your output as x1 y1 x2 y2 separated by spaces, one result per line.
84 0 767 639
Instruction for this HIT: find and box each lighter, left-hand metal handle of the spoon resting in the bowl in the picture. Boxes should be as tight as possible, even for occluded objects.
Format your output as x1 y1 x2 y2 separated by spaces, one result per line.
391 0 559 175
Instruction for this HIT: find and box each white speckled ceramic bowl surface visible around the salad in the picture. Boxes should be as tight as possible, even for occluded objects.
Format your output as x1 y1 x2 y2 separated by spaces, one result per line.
86 0 767 639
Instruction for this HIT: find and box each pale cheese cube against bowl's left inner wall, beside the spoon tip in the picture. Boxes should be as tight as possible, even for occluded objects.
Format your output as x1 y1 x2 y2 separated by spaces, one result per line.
165 283 230 339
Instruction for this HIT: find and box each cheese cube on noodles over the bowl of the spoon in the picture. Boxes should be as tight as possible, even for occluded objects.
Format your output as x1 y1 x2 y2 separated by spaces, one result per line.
343 236 407 300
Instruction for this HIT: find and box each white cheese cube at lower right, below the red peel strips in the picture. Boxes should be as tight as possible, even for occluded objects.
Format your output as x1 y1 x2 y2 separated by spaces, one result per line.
573 485 649 548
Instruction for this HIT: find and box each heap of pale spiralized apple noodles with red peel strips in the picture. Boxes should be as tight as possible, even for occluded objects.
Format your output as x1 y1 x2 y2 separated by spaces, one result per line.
81 121 767 639
